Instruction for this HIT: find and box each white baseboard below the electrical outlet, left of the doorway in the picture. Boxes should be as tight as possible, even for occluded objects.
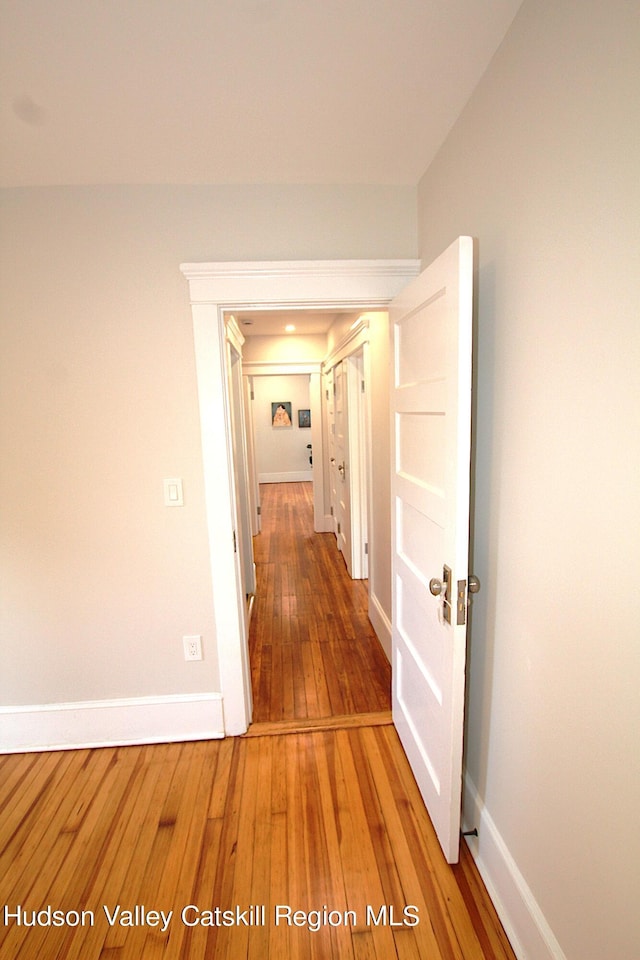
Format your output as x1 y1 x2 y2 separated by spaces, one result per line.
0 693 224 753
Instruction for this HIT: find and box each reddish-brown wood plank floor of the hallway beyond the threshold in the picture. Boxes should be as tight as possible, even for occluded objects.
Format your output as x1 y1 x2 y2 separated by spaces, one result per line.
249 483 391 723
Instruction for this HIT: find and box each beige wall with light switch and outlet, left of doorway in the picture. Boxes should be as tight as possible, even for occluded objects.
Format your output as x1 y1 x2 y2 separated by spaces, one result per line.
0 187 416 705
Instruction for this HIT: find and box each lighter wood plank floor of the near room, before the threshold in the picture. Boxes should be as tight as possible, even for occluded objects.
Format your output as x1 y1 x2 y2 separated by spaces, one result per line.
0 725 515 960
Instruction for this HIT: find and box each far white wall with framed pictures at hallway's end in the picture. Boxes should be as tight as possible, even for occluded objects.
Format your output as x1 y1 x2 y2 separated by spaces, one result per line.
252 374 313 483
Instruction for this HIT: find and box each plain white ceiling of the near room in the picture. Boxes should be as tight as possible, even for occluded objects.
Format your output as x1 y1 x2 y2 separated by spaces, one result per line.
0 0 521 186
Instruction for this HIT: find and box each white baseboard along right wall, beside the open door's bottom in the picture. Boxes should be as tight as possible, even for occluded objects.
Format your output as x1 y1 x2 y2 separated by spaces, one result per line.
463 774 566 960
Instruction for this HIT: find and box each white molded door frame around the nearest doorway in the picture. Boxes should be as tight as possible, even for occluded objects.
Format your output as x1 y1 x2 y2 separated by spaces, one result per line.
180 260 420 735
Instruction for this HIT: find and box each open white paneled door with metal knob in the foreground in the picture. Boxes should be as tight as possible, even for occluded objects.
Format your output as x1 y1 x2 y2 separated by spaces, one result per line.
389 237 473 863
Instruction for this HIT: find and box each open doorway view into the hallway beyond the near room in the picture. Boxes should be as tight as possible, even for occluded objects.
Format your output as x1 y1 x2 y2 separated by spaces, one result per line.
232 310 391 723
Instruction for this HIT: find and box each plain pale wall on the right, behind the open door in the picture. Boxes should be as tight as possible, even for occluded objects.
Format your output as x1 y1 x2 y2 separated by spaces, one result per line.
419 0 640 960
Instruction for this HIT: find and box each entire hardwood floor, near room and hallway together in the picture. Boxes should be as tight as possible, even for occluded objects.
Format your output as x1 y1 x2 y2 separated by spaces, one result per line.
0 484 515 960
